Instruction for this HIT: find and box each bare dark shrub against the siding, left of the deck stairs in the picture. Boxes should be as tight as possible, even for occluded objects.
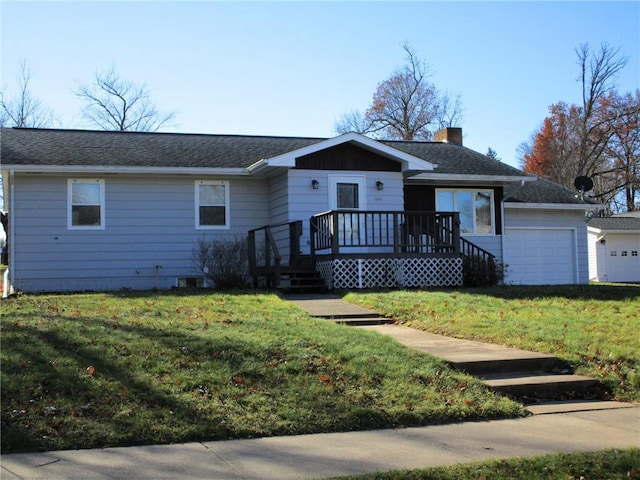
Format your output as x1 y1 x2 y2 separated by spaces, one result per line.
193 238 249 290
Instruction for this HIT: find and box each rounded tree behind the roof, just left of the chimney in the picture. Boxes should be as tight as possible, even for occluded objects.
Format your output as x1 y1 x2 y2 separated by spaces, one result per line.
334 43 462 140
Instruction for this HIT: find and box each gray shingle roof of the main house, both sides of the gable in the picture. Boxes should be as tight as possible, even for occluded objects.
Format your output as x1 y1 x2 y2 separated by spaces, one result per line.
0 128 582 204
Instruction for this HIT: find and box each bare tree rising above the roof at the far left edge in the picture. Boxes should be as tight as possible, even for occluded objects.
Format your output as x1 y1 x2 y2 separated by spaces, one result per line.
0 60 54 128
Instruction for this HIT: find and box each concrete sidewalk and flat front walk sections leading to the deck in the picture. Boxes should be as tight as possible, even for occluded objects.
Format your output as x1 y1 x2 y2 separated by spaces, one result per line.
0 296 640 480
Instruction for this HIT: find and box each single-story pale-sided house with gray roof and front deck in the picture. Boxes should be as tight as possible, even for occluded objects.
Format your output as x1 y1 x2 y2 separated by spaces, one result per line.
1 128 597 292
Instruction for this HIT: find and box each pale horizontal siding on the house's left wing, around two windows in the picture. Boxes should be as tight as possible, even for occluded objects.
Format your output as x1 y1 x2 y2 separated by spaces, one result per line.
12 175 269 292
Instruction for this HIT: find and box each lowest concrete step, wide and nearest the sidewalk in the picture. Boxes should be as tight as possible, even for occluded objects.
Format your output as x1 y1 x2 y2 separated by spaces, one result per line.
480 372 607 404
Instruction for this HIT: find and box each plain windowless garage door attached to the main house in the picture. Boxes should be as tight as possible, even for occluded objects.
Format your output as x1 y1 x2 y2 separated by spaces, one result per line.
504 228 576 285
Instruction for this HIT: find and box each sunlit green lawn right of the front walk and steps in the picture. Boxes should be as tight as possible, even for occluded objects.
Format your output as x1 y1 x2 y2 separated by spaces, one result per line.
345 285 640 401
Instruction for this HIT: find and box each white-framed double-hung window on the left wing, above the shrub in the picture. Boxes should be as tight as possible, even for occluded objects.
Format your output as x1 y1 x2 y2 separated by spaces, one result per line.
196 180 229 229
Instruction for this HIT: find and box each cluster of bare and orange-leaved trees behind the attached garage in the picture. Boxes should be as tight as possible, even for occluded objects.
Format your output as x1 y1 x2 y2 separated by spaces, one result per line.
522 43 640 211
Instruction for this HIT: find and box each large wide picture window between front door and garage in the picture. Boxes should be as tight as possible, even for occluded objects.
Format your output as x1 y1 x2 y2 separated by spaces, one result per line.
436 189 494 234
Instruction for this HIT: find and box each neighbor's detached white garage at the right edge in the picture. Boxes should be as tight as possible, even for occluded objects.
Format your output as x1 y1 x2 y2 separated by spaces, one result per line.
588 212 640 282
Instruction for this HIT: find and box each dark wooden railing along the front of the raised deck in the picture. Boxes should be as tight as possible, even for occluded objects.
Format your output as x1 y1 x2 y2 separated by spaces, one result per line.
309 210 460 258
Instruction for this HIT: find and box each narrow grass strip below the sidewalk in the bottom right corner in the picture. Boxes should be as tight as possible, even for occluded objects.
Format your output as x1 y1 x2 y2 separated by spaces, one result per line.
332 448 640 480
